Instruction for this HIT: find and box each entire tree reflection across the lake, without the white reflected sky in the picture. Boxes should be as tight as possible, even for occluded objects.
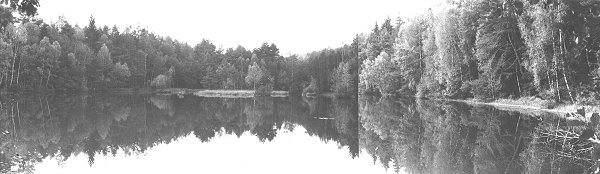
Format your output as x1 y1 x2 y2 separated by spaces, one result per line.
0 95 598 173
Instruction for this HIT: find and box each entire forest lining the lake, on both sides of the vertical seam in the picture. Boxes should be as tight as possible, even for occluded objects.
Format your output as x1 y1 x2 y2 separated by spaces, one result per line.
0 0 600 103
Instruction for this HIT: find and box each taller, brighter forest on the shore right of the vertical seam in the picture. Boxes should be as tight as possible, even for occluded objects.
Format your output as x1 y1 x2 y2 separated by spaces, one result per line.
358 0 600 103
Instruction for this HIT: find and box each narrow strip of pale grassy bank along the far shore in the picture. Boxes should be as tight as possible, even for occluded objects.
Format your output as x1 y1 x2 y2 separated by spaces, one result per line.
155 88 289 98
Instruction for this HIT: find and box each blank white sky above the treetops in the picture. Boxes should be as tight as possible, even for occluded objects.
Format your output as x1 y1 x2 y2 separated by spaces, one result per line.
38 0 440 56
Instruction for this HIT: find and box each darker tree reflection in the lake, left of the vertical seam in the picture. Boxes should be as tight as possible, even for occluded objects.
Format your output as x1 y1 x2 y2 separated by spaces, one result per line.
0 95 358 173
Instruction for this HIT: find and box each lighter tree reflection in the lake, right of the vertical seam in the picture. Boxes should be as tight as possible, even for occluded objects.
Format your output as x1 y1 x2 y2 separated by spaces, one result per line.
359 97 590 173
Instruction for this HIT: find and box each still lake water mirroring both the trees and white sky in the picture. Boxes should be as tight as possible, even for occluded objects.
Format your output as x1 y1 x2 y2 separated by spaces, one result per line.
0 95 597 173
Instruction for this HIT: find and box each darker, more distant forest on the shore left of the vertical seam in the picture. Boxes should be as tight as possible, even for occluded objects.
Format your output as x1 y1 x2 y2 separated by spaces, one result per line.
0 7 358 97
